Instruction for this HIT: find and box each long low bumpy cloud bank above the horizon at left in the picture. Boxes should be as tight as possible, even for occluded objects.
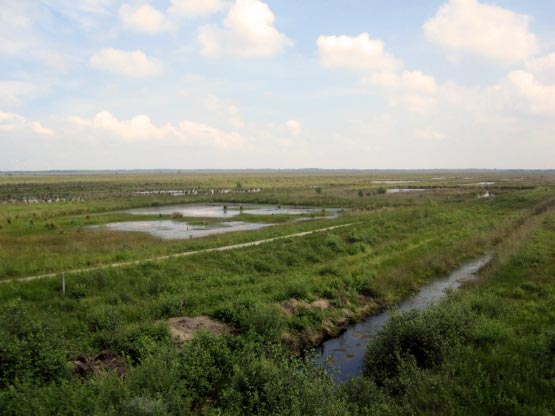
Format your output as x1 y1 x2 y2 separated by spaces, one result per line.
68 111 245 148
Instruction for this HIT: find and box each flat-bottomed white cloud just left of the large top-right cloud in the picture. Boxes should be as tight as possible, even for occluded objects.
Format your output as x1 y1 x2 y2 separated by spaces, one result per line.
316 33 402 72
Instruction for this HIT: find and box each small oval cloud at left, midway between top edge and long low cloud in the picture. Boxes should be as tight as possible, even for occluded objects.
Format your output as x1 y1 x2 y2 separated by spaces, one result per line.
90 48 162 78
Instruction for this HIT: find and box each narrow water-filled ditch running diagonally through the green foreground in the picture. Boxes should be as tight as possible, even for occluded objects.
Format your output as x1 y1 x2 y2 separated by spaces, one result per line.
317 255 491 382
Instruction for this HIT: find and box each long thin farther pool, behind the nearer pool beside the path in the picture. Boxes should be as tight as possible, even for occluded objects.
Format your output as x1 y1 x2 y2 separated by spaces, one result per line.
125 204 338 218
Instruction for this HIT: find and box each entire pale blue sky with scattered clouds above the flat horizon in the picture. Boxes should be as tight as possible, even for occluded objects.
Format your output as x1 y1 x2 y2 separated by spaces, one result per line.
0 0 555 171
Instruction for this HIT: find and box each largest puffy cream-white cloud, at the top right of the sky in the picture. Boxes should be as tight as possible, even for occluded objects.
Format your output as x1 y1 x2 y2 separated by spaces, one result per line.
423 0 538 64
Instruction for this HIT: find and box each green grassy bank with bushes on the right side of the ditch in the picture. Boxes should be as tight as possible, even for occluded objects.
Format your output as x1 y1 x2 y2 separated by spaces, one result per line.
352 204 555 415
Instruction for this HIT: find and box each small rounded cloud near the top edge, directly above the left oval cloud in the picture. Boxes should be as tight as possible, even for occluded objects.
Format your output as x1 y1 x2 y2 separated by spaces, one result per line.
119 4 172 35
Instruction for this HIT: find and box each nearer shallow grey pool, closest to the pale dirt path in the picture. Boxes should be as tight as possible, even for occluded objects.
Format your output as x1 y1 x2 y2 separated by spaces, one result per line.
105 220 270 240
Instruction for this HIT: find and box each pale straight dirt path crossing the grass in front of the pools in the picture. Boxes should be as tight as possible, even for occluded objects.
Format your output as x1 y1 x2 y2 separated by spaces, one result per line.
4 223 353 283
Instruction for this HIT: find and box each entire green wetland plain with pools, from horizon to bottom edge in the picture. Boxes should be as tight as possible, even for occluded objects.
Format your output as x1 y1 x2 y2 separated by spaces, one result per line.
0 171 555 415
